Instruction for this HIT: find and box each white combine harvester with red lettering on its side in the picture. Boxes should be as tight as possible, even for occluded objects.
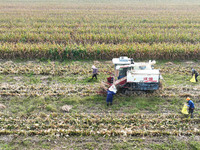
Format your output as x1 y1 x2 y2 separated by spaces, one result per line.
102 57 162 93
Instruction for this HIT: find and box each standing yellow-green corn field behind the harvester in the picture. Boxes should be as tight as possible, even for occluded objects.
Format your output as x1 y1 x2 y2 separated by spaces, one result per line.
0 1 200 60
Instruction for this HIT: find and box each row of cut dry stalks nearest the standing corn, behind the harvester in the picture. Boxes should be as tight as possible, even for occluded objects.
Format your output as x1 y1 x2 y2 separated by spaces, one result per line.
0 60 200 76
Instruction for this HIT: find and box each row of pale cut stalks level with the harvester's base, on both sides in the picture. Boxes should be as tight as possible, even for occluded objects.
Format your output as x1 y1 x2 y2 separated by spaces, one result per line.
0 82 200 98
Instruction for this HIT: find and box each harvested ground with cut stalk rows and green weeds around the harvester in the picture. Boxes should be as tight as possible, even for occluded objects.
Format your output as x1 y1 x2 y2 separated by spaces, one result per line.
0 61 200 149
